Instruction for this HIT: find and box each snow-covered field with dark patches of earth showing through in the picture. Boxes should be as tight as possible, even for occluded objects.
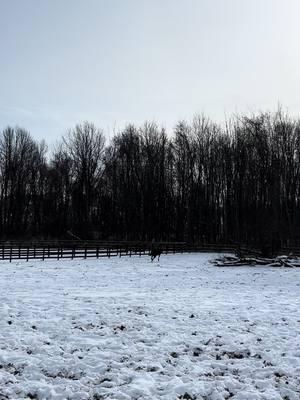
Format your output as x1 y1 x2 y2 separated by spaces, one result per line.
0 254 300 400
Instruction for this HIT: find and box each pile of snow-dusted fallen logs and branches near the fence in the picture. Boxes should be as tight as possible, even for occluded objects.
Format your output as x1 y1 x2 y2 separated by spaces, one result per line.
212 255 300 268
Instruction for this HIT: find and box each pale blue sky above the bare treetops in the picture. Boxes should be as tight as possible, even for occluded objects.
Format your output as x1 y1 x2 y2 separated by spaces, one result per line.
0 0 300 144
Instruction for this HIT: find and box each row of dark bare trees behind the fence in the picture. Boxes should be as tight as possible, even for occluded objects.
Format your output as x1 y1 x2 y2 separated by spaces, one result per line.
0 110 300 247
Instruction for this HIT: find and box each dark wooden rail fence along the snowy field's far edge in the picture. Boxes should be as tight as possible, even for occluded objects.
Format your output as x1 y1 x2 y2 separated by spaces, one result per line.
0 240 235 261
